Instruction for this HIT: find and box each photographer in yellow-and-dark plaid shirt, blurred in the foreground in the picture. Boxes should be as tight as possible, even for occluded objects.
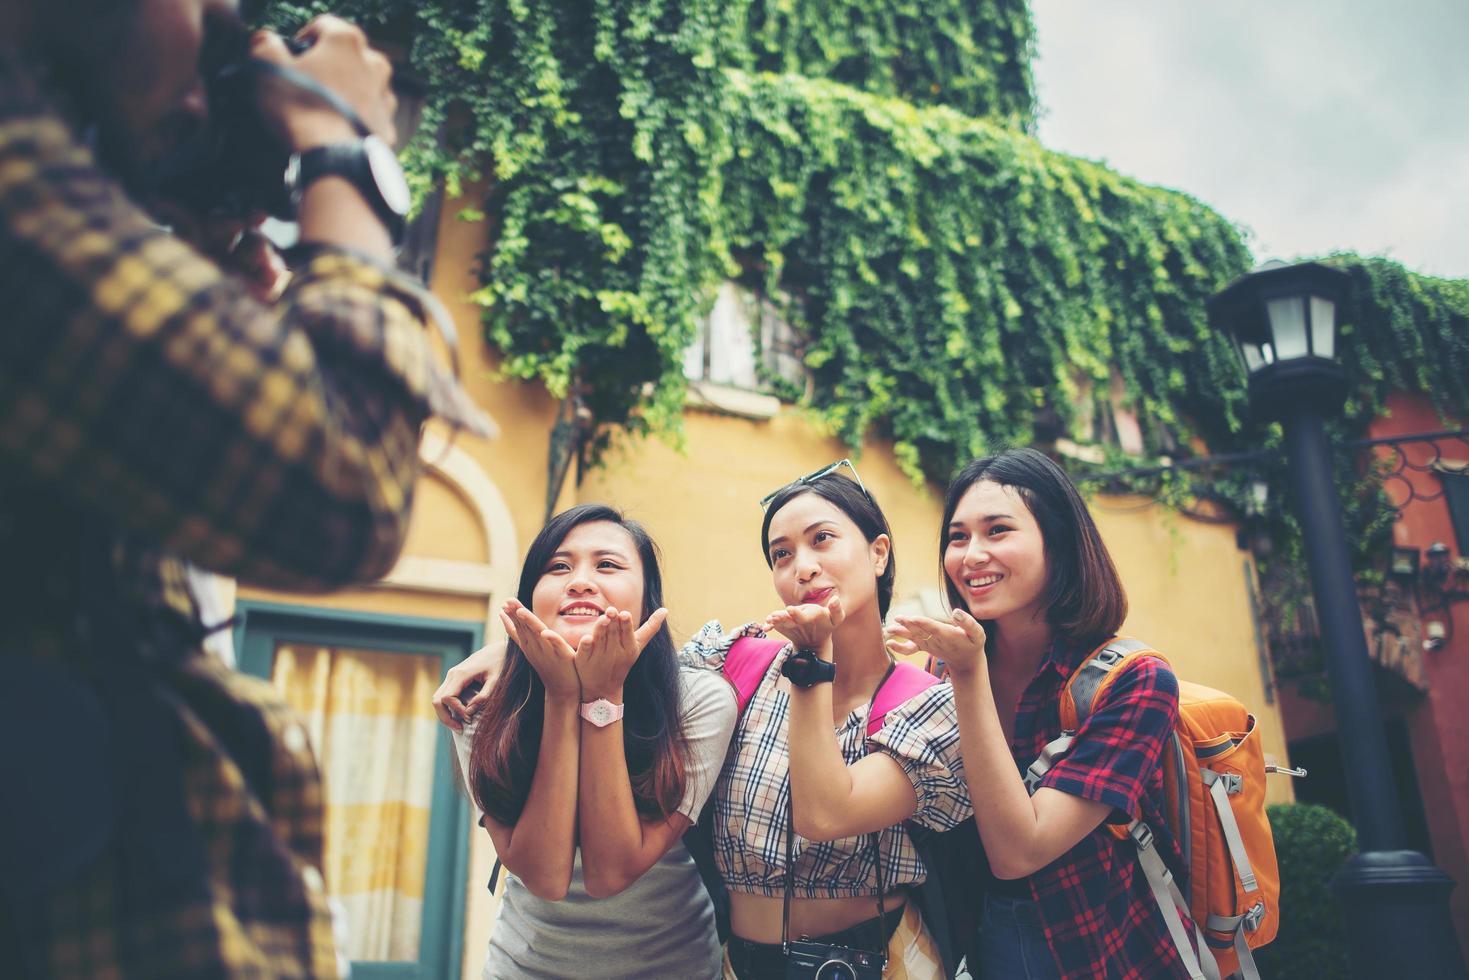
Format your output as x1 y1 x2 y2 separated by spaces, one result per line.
0 0 488 980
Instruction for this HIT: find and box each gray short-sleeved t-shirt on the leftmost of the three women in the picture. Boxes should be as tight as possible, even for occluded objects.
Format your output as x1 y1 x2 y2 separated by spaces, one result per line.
483 667 737 980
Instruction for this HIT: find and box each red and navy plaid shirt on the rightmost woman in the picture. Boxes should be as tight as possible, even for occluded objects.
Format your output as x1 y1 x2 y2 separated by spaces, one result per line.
1011 645 1188 980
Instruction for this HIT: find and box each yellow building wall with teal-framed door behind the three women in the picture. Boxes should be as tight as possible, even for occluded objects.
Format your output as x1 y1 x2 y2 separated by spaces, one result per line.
220 201 1298 977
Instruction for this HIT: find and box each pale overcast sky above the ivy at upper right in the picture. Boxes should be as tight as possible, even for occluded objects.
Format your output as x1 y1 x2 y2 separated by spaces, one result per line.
1031 0 1469 278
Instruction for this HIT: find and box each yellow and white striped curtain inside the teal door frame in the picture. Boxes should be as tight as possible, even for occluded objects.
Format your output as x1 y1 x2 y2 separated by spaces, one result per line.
270 645 442 961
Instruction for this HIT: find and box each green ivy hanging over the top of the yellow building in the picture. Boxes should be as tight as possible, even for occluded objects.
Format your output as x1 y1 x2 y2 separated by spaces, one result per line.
258 0 1469 492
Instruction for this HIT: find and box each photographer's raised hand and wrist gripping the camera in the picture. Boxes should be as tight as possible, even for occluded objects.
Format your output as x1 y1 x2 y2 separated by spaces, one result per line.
250 16 398 262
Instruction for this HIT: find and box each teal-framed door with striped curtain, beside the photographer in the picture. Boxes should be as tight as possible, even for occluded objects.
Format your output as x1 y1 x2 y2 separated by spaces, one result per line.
235 601 483 980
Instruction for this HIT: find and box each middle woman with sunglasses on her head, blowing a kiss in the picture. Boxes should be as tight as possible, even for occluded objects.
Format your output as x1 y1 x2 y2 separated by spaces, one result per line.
683 460 971 980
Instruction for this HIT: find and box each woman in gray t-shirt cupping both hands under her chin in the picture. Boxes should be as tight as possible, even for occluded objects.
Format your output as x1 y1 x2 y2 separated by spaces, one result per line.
449 504 736 980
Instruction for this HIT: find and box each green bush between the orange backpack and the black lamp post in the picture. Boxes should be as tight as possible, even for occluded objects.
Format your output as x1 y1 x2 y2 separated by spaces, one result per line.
1255 804 1357 980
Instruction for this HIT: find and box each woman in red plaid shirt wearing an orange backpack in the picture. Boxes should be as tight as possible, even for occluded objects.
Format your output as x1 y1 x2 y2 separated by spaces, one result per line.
890 450 1188 980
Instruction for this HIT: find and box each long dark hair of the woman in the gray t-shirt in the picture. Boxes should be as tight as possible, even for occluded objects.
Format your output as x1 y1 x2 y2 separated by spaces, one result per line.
470 504 687 824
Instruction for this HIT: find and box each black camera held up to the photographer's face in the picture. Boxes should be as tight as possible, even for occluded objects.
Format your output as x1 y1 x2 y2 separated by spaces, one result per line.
151 10 310 220
